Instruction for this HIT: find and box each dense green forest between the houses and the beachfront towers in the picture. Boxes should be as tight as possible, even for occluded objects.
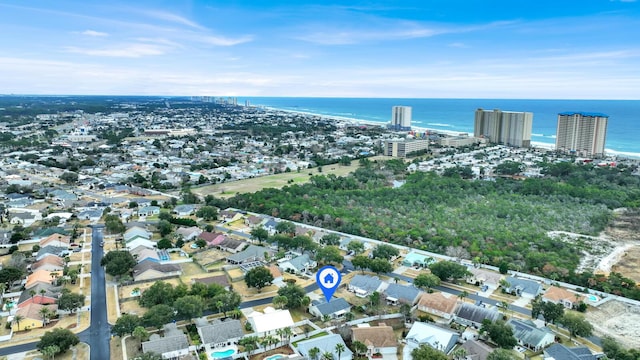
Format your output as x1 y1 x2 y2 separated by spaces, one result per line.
227 160 640 300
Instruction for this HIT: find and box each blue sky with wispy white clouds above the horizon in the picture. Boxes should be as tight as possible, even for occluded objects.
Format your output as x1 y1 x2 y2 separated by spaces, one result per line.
0 0 640 99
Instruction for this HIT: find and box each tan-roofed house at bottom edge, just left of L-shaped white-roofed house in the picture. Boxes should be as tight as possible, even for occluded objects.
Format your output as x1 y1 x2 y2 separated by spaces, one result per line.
351 324 398 360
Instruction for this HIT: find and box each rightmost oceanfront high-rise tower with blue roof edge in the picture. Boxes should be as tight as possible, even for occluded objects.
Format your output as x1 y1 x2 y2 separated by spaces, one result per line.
556 112 609 156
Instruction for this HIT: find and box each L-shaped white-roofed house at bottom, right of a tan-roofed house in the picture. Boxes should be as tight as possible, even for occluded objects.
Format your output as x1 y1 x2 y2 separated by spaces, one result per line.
402 322 460 360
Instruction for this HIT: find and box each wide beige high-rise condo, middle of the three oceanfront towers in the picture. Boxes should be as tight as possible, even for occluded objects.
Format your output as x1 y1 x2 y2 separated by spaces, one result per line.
473 109 533 147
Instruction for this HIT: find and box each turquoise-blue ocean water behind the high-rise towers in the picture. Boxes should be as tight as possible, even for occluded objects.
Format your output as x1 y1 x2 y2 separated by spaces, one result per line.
238 97 640 158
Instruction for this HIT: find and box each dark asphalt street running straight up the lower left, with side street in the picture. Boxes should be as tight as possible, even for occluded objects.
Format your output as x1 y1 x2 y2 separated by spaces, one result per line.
0 225 111 360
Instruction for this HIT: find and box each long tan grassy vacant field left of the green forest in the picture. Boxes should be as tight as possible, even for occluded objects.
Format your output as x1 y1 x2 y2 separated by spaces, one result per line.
193 160 358 198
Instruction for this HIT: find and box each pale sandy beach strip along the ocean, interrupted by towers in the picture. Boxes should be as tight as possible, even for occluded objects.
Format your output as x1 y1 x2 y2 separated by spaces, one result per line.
261 106 640 160
